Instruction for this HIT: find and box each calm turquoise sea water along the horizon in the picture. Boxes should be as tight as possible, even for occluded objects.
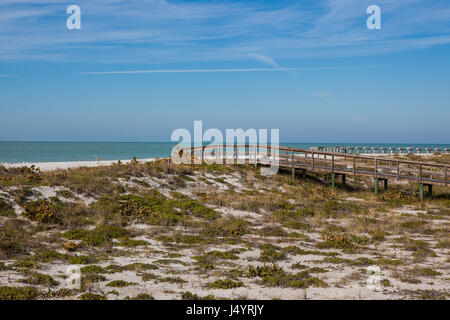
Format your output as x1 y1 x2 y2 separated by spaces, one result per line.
0 142 450 163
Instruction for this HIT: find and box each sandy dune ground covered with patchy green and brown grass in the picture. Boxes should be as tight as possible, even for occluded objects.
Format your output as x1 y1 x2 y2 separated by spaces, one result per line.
0 162 450 299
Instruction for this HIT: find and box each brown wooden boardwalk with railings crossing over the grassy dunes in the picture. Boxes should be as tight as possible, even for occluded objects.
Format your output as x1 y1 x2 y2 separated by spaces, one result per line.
180 145 450 196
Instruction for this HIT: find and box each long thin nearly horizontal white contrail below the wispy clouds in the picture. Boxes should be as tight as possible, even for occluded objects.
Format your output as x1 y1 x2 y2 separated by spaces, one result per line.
76 67 367 75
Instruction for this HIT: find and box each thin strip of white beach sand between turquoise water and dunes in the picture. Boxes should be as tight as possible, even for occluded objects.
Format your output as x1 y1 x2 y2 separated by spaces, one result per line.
0 158 162 171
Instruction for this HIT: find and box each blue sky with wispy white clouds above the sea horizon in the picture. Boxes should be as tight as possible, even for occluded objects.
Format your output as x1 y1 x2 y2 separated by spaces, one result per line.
0 0 450 143
